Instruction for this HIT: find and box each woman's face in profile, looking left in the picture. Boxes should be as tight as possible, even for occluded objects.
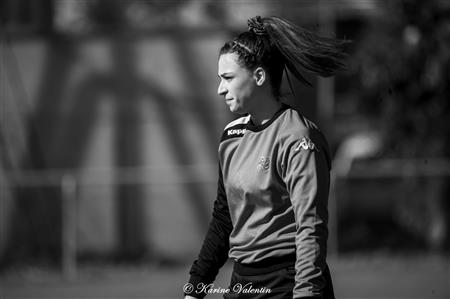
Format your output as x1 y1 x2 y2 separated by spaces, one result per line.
217 53 256 114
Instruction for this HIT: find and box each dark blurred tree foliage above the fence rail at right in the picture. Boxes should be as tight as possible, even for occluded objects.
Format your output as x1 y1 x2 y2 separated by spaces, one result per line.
355 0 450 158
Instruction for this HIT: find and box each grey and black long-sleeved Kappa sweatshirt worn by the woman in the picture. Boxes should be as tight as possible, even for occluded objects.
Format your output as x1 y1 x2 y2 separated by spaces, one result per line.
189 105 331 298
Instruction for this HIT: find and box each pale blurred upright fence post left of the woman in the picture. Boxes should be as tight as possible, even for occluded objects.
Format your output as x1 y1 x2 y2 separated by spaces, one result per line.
61 174 77 281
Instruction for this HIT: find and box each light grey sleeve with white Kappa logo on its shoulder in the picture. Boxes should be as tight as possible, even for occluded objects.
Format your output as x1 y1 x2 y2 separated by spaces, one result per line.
282 129 330 298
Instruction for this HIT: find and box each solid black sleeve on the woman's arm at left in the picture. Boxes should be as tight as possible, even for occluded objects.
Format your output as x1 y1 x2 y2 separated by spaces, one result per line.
185 168 233 298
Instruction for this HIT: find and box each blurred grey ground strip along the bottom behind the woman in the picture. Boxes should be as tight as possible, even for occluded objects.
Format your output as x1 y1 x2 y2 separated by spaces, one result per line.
0 256 450 299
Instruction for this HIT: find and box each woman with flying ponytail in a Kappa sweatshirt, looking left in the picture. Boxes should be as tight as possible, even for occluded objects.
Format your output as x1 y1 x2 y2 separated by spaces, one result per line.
184 17 344 299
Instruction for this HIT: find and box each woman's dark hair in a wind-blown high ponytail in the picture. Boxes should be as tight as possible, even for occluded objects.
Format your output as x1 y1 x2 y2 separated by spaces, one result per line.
219 16 347 96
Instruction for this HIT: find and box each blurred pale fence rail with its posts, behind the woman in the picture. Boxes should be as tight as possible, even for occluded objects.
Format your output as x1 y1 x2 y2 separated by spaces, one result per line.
0 158 450 280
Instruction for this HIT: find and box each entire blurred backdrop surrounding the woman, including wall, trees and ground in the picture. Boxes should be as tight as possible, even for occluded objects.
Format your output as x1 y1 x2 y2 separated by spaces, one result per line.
0 0 450 299
